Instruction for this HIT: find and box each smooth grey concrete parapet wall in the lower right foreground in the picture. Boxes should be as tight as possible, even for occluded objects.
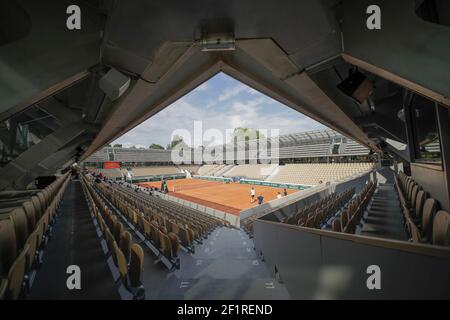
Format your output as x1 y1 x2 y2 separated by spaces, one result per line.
254 220 450 299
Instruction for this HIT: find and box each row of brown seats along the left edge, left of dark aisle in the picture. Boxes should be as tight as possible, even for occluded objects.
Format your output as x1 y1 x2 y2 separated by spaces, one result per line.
0 173 69 300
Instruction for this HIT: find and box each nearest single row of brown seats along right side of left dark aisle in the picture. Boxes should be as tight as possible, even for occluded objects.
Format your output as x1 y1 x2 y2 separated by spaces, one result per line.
82 177 145 299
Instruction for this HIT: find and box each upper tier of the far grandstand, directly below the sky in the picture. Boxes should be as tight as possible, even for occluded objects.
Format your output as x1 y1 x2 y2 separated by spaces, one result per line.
84 129 369 165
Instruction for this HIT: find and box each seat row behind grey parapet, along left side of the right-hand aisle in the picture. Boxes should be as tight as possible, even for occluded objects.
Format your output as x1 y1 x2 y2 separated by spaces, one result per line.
331 181 377 233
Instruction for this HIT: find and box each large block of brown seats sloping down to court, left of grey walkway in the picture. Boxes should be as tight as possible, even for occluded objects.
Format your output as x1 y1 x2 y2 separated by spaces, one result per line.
83 174 229 267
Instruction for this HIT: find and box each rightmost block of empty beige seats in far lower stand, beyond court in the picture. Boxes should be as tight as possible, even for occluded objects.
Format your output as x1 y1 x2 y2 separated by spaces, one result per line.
268 163 374 185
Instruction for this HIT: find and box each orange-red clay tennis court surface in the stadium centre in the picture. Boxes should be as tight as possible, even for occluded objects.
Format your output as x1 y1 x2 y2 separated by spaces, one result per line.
139 179 298 215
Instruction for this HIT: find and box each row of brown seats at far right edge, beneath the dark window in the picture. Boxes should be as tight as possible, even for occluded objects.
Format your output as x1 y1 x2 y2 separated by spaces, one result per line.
395 172 450 246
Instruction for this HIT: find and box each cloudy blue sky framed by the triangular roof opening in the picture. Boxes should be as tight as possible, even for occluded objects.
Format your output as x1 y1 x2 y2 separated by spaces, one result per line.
112 73 326 148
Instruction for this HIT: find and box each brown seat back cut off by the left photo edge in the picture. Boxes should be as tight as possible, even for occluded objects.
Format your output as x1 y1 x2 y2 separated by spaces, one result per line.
0 219 17 276
